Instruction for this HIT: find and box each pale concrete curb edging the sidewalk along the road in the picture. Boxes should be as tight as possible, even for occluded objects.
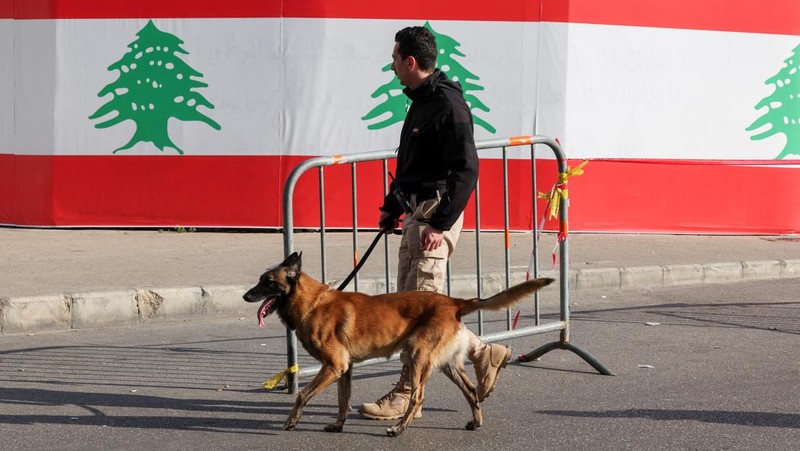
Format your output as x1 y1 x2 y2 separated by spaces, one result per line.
0 260 800 334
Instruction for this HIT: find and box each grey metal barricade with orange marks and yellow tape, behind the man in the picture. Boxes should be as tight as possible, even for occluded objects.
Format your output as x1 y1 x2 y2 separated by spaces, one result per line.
283 136 613 393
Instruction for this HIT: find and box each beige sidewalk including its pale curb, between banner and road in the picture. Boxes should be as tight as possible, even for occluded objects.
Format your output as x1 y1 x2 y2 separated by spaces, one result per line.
0 228 800 333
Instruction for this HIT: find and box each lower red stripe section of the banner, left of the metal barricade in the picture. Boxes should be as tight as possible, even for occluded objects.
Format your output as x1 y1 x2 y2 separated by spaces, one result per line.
0 155 280 226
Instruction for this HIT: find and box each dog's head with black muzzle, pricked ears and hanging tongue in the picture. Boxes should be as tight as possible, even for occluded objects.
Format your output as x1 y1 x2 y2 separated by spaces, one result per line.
243 252 302 327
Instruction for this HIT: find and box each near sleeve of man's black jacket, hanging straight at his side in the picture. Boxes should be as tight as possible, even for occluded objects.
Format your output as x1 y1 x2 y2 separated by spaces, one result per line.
429 109 478 230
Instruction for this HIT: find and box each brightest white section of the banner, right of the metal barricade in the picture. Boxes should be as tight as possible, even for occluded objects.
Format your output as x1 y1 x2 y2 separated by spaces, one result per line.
566 24 800 160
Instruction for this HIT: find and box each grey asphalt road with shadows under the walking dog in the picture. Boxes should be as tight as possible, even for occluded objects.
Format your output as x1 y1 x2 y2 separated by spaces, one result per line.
0 280 800 451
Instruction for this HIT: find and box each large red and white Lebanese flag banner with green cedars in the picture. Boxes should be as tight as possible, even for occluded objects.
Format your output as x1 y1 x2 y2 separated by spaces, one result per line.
0 0 800 234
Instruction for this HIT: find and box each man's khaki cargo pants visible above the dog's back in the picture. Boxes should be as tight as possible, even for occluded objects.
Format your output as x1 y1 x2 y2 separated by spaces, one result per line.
397 195 464 293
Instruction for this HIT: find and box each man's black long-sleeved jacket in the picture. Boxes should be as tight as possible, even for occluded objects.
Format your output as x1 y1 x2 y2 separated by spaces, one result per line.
381 69 478 230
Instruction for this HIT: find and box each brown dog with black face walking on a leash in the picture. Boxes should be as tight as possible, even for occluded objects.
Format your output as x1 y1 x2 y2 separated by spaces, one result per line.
244 252 553 436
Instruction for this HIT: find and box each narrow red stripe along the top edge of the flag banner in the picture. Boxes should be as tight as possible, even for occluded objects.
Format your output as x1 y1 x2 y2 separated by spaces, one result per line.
0 0 800 34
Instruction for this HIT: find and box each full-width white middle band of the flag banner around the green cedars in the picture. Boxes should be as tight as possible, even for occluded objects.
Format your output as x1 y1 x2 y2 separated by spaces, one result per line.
6 19 800 160
